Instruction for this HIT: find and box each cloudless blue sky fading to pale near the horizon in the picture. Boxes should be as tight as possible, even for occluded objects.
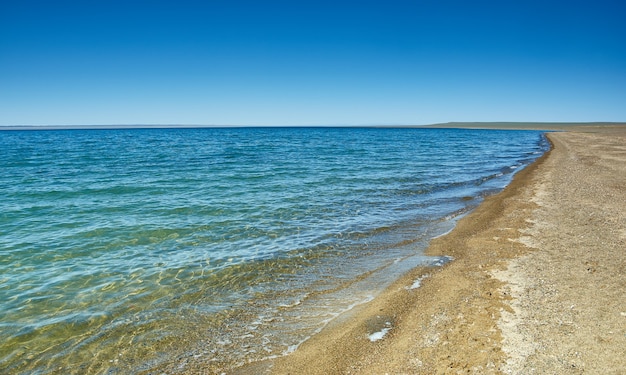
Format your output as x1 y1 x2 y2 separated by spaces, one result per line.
0 0 626 125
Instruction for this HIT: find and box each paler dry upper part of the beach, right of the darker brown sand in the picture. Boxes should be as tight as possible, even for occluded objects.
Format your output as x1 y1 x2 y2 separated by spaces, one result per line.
496 133 626 374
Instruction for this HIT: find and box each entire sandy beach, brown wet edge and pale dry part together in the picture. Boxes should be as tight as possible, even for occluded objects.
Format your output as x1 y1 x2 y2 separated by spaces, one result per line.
235 125 626 374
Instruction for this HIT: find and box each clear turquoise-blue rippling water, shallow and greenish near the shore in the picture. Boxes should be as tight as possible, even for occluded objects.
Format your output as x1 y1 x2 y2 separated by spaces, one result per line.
0 128 547 374
